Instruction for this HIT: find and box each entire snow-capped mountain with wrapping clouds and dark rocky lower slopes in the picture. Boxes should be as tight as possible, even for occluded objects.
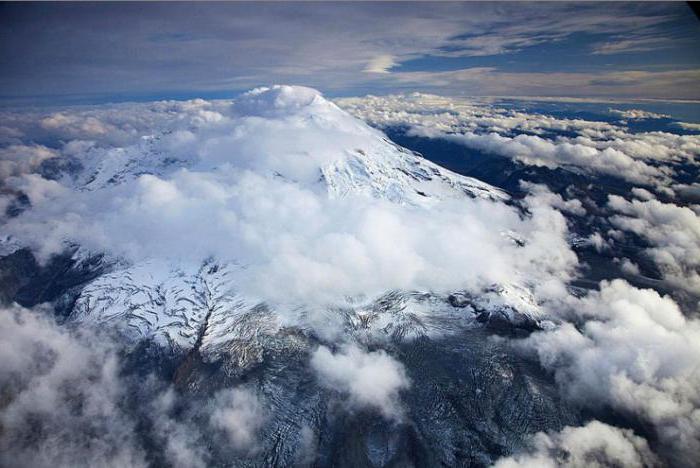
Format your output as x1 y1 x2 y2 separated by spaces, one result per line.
0 86 592 466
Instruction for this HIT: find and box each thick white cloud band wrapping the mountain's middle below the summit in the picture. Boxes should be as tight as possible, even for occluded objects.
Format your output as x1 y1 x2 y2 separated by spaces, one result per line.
8 171 576 299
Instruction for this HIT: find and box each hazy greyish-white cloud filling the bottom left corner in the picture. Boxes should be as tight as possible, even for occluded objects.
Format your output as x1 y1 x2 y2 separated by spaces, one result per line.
0 307 147 467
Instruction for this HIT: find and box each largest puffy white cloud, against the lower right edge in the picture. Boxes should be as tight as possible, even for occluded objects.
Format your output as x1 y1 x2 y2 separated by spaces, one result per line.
525 280 700 464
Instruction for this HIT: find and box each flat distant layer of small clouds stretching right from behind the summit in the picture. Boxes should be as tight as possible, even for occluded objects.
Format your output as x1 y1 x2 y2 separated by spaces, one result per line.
338 93 700 185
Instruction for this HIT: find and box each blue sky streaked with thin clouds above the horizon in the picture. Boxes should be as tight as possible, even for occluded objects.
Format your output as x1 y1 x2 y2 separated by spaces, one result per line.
0 2 700 105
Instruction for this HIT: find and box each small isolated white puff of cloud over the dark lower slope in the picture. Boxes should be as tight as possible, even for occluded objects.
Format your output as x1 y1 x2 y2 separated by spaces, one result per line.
311 345 410 419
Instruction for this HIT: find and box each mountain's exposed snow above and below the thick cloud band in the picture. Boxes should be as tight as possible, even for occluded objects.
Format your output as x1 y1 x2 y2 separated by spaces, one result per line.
1 86 564 358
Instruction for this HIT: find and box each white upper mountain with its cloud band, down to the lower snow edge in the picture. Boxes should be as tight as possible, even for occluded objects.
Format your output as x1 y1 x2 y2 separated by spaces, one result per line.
1 86 575 354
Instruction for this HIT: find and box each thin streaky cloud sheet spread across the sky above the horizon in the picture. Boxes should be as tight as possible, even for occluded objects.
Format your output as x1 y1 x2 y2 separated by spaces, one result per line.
0 2 697 99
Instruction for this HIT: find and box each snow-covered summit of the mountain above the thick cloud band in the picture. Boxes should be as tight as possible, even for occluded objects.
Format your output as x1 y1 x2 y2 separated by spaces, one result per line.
60 86 506 205
